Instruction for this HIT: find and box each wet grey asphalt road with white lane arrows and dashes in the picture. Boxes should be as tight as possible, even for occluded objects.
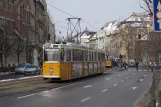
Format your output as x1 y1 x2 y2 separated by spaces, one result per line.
0 68 152 107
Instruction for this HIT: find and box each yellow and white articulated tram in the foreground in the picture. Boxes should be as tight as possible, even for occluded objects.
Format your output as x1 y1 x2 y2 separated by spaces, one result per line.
43 43 105 81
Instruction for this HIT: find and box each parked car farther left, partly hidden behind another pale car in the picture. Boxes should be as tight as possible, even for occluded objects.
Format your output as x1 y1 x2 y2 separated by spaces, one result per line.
15 63 30 74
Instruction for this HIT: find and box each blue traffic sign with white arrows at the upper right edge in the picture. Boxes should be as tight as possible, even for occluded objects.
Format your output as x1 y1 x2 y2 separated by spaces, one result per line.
153 0 161 32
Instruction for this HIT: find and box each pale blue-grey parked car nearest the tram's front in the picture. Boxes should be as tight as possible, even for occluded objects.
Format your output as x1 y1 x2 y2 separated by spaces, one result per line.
24 64 41 75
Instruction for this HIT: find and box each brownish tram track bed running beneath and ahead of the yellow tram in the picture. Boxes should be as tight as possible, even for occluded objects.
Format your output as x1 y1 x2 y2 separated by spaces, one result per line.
0 70 112 97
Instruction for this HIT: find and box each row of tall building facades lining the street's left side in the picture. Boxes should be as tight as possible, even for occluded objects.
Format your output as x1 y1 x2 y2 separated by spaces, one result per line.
0 0 52 66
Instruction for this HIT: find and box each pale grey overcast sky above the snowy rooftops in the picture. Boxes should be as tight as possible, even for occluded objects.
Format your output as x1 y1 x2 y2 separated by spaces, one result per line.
46 0 143 36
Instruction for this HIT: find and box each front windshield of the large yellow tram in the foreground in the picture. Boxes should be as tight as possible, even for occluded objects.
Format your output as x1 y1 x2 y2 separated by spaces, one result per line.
44 49 60 61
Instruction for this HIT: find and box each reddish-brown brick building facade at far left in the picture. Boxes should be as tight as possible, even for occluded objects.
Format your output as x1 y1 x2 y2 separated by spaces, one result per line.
0 0 28 66
